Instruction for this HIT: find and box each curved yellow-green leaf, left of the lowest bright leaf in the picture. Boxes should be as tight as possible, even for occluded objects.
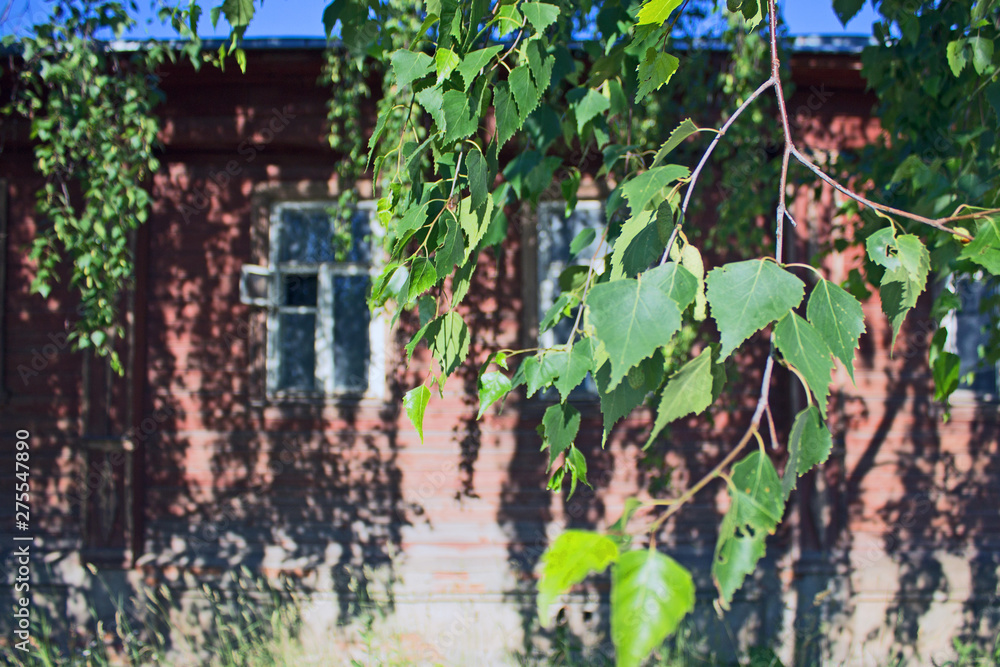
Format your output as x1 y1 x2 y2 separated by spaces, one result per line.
538 530 618 627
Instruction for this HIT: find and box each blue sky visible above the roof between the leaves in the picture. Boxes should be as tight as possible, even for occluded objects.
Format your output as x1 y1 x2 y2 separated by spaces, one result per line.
0 0 875 37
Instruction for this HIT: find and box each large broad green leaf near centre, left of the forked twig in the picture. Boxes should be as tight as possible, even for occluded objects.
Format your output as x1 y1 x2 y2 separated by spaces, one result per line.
587 267 681 388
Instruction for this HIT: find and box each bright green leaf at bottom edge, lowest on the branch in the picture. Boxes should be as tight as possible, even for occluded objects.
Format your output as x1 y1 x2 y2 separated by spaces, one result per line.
611 549 695 667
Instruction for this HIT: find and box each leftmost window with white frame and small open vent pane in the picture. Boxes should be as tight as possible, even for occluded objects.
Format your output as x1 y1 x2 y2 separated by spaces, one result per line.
241 201 383 396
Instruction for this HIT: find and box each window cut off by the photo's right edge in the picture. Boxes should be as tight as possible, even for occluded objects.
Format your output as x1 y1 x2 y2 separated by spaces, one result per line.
944 274 1000 396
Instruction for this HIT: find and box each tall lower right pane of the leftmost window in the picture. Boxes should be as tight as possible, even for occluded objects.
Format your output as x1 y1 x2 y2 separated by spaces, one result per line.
333 276 370 392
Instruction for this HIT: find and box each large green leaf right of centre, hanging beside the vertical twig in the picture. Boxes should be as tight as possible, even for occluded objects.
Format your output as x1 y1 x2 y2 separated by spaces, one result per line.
705 259 805 360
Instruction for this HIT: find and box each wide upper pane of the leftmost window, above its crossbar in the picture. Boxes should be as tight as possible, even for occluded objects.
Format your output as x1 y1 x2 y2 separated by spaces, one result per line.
278 204 371 263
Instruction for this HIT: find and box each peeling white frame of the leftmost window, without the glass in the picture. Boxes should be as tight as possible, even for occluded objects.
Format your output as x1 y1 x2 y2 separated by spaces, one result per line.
240 198 386 399
